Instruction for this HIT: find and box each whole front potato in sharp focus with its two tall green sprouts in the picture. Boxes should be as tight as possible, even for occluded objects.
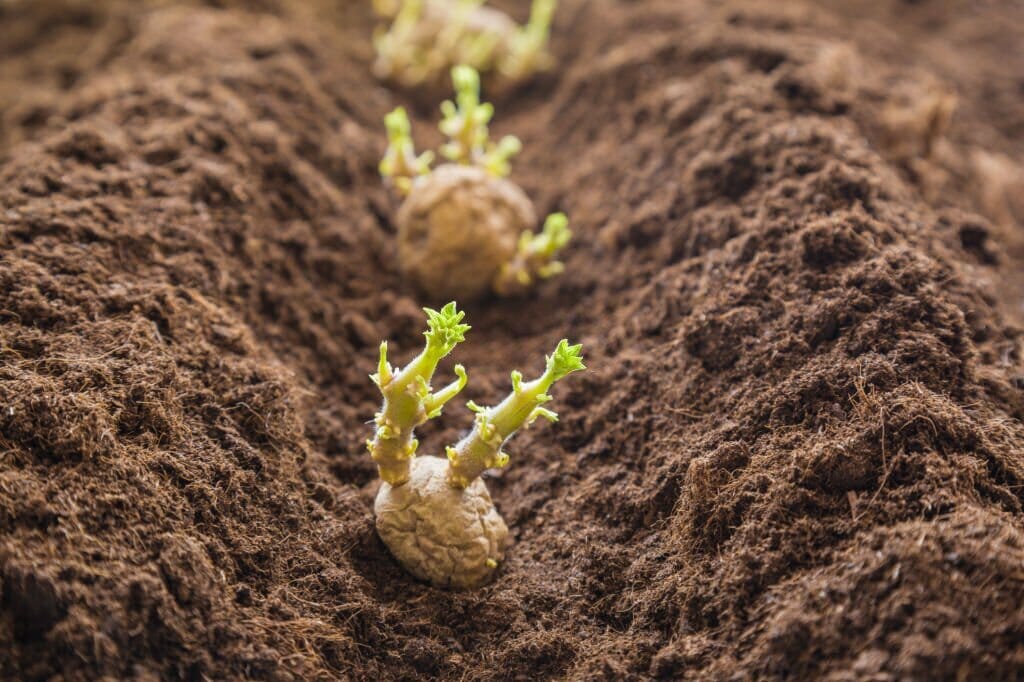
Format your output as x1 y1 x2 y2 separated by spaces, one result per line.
368 302 586 589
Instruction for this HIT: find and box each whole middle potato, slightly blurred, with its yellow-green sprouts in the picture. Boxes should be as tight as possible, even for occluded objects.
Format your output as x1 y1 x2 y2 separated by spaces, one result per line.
380 65 571 300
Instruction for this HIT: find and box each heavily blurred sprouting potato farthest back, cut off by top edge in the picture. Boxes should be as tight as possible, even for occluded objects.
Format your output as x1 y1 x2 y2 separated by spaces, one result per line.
374 0 557 87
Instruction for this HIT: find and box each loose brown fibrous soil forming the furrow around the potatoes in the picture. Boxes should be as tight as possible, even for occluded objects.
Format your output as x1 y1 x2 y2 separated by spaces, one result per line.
0 0 1024 680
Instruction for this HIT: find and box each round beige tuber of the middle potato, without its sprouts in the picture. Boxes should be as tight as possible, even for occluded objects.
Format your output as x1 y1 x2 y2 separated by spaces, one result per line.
397 164 537 301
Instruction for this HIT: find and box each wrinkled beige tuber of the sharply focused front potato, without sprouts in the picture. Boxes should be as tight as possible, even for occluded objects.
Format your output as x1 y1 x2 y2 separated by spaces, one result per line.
374 457 509 590
